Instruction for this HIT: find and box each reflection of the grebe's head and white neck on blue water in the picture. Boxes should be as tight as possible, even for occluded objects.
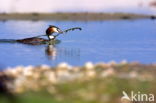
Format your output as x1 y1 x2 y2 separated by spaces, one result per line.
45 44 57 60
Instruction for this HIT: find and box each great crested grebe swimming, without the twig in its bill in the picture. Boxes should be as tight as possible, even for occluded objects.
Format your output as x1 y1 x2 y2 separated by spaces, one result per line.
16 25 63 44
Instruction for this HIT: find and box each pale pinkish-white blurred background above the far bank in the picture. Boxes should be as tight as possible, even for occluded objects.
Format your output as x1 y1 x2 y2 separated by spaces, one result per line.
0 0 156 14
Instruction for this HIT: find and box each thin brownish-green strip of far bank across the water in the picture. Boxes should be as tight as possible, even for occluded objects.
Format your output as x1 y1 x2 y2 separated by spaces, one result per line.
0 13 156 21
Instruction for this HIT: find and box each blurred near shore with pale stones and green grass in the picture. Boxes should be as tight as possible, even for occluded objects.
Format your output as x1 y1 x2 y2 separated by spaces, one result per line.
0 61 156 103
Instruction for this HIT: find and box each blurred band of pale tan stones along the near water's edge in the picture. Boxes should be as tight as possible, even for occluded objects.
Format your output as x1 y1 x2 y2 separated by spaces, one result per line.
0 61 156 93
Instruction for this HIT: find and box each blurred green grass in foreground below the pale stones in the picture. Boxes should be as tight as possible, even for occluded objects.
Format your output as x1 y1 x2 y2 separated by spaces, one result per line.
0 77 156 103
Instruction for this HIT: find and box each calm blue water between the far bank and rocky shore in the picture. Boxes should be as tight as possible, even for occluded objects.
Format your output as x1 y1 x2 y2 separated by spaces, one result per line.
0 19 156 67
